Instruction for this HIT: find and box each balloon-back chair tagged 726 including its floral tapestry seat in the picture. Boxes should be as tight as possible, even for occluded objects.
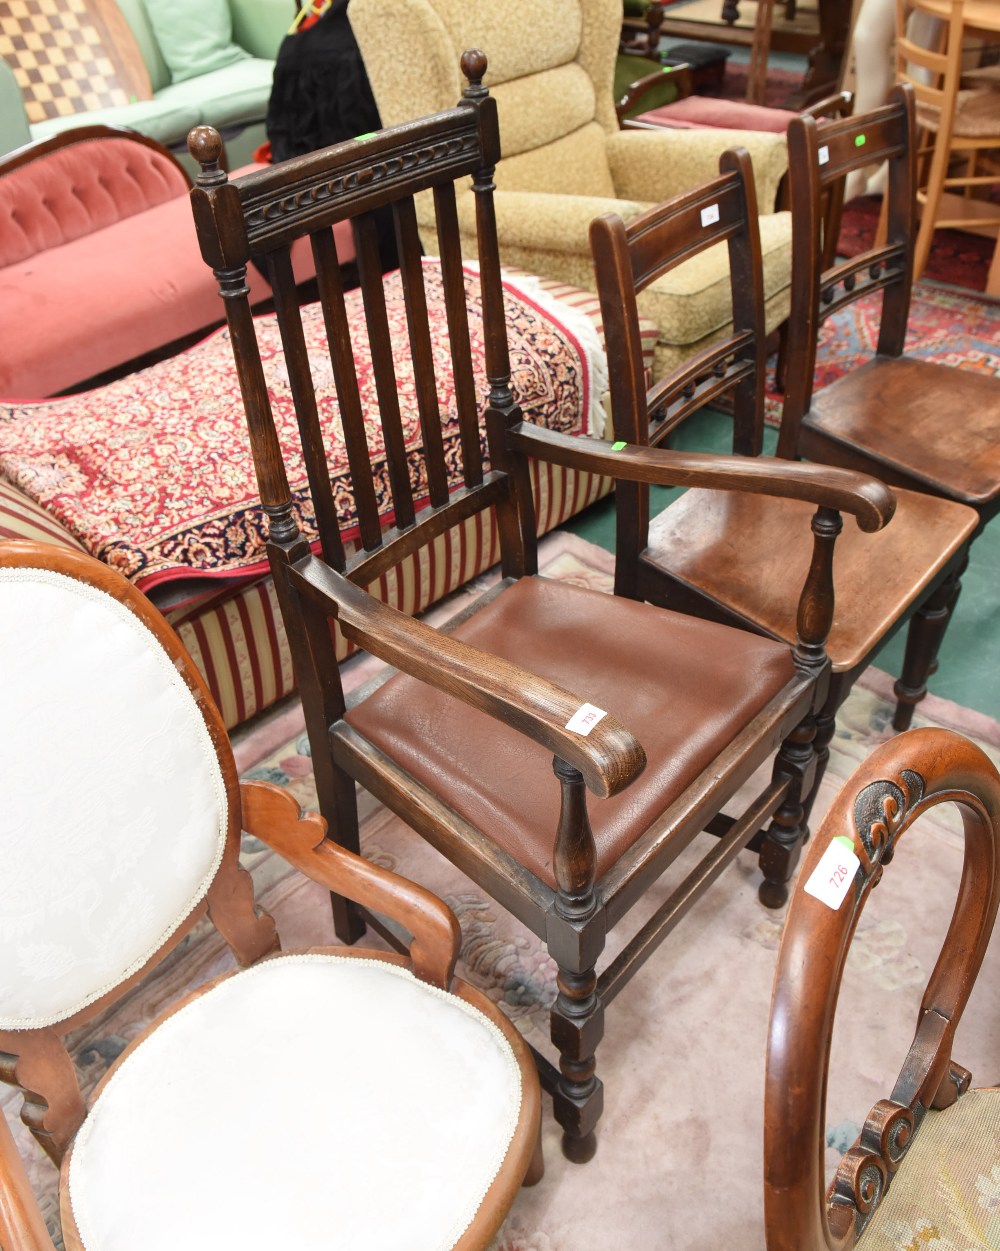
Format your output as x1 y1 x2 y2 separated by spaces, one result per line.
763 729 1000 1251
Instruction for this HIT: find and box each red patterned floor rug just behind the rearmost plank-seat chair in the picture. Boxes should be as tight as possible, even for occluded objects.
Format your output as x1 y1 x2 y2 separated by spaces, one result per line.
766 281 1000 425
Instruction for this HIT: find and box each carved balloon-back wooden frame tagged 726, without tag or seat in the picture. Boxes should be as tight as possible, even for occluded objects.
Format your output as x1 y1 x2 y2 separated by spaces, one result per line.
763 729 1000 1251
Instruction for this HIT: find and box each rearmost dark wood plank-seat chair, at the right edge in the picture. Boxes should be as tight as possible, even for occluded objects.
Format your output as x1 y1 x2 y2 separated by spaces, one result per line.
778 85 1000 729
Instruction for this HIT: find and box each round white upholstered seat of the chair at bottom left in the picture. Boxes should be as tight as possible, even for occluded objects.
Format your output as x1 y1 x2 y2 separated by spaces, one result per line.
63 952 521 1251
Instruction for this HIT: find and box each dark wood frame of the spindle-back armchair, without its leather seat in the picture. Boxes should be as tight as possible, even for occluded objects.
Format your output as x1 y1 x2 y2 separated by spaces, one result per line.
190 53 891 1161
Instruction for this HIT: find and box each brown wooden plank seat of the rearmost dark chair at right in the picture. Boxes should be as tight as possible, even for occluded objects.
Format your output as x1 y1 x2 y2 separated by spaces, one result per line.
800 357 1000 507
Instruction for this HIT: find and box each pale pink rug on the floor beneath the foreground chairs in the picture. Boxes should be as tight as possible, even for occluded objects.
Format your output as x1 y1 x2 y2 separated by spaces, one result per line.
9 533 1000 1251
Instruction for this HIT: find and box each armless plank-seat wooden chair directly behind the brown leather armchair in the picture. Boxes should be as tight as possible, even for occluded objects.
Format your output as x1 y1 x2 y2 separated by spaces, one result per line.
591 141 976 907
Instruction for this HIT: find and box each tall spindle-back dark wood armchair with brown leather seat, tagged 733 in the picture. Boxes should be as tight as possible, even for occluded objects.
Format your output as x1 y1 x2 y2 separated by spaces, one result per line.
190 53 892 1161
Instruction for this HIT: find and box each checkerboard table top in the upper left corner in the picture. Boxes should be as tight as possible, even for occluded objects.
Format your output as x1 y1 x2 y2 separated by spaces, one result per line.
0 0 153 123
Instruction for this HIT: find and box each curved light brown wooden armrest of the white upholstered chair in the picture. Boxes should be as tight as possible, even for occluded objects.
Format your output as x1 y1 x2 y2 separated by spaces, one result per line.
239 782 462 990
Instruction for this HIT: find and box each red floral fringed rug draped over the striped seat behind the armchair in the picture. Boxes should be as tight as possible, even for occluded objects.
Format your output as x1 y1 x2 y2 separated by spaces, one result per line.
0 259 607 592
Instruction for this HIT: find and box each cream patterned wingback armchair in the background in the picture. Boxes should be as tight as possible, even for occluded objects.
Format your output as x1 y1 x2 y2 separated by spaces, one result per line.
350 0 791 377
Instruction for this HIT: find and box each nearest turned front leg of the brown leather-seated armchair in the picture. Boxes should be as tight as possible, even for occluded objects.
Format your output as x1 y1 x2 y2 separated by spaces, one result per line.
551 966 605 1165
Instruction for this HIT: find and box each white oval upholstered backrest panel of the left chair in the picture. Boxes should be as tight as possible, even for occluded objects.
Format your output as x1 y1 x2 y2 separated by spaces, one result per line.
0 569 227 1030
